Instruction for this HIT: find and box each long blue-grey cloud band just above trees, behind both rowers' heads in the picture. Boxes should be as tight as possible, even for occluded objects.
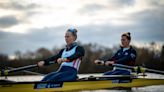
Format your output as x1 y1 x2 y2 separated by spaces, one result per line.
0 24 164 54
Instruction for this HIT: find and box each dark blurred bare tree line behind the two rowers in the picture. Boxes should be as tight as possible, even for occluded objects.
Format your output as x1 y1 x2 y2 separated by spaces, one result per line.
0 42 164 75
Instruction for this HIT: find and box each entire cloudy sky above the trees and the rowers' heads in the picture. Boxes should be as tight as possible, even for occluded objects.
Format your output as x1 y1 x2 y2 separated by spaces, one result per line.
0 0 164 54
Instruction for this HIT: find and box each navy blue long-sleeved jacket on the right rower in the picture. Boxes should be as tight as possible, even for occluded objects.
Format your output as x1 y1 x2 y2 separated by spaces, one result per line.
107 46 137 66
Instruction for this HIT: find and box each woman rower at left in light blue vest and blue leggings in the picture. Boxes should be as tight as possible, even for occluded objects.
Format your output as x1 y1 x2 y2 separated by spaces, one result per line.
38 28 85 81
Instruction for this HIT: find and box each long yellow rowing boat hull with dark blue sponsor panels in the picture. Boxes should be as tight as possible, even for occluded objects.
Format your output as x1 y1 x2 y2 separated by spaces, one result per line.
0 75 164 92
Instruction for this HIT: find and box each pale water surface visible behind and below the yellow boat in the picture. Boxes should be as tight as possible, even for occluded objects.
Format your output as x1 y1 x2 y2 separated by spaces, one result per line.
0 74 164 92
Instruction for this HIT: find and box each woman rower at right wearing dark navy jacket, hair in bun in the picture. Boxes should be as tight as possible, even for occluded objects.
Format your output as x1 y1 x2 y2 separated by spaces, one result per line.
94 32 137 75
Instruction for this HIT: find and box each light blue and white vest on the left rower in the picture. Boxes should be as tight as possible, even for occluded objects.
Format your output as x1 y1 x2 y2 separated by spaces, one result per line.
60 46 81 70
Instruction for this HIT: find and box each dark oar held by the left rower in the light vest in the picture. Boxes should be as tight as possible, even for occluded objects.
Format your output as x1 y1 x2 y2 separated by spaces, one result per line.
0 61 55 76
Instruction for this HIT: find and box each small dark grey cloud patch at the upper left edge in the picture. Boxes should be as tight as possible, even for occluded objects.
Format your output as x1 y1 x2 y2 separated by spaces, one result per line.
0 15 19 28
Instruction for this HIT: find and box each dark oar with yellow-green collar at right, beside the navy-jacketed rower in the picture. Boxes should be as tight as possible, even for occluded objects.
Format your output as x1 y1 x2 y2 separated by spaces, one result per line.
112 64 164 74
